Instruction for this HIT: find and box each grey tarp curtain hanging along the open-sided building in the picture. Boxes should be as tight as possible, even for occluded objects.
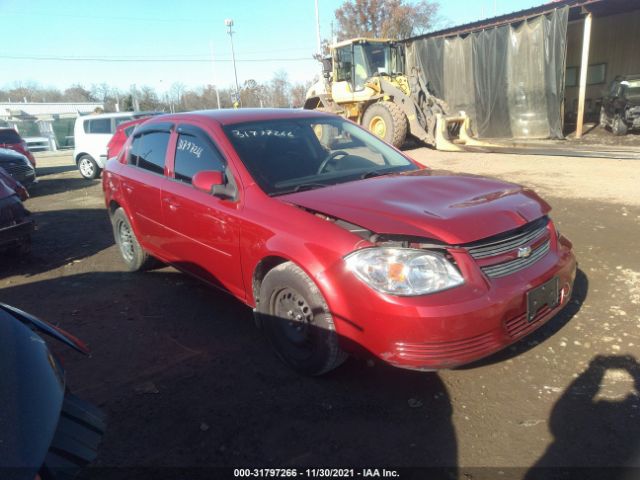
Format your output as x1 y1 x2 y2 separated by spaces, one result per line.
407 7 569 138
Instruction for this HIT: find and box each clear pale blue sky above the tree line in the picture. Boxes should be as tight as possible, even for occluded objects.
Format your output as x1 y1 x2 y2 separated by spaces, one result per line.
0 0 543 92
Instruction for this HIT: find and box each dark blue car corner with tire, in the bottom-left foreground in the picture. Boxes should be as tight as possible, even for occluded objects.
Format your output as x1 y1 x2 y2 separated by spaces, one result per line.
0 303 105 480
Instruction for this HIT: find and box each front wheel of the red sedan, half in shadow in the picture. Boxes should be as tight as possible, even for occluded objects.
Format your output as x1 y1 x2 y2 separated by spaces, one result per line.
256 262 347 375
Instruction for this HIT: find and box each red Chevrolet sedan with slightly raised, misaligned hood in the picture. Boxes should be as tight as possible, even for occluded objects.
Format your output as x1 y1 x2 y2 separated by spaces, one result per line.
103 110 576 375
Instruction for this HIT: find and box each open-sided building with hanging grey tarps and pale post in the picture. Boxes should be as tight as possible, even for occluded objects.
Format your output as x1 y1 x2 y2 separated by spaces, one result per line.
407 0 640 138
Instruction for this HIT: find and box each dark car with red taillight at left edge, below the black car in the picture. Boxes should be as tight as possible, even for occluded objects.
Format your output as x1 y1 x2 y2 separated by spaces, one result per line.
0 167 34 256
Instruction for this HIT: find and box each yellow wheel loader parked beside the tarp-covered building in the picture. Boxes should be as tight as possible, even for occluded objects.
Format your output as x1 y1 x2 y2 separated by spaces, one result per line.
304 38 473 151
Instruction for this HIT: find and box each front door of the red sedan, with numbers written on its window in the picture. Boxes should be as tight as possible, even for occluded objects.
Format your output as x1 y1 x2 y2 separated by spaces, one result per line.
162 124 245 298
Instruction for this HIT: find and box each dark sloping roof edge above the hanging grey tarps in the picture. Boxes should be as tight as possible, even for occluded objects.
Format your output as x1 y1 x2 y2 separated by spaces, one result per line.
405 0 640 41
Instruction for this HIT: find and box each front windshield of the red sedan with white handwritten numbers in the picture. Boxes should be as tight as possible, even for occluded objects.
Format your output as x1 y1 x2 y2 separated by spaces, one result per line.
224 116 418 195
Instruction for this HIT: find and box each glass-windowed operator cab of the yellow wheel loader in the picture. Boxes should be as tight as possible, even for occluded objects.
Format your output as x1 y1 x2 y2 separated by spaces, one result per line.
331 39 404 103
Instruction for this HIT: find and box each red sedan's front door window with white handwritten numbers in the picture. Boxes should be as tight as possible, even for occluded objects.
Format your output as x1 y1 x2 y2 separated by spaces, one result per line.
174 133 225 183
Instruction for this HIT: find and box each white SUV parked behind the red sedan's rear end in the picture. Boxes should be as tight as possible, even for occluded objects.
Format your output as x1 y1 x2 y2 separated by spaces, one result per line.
73 112 157 179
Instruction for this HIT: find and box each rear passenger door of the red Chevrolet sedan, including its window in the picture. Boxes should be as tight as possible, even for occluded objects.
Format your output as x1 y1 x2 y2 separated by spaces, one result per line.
121 123 172 253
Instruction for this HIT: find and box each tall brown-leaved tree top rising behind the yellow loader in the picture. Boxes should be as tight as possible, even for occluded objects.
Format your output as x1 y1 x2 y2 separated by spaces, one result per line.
335 0 439 40
